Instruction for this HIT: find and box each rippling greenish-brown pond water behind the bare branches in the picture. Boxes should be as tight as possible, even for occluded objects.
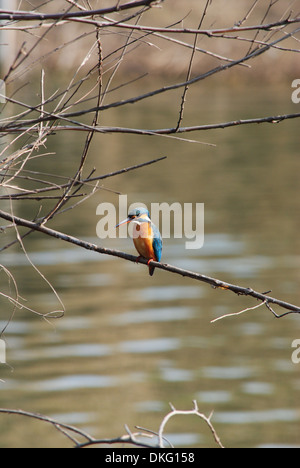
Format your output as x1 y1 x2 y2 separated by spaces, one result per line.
0 82 300 447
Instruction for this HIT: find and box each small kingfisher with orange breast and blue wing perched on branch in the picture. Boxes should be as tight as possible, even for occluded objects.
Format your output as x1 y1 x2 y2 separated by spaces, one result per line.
116 208 162 276
